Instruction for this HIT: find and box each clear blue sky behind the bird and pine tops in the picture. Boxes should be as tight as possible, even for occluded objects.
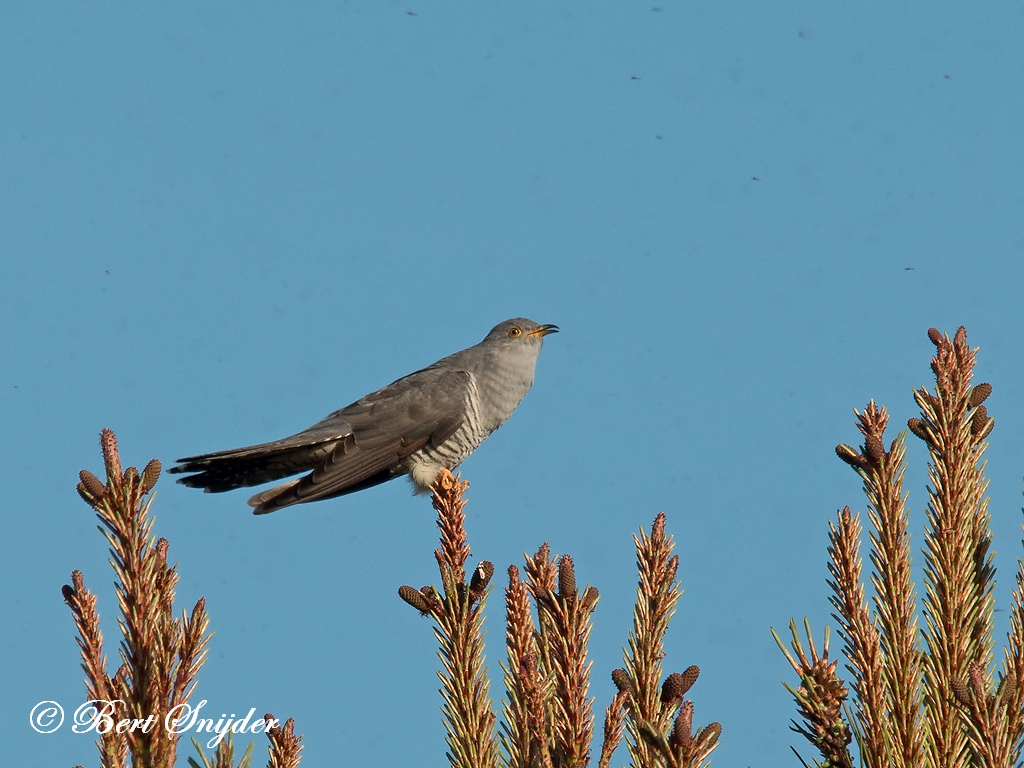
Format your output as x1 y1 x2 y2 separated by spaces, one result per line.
6 0 1024 766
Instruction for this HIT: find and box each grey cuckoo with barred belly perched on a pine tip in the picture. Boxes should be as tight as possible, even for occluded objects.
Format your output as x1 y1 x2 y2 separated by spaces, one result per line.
170 317 558 515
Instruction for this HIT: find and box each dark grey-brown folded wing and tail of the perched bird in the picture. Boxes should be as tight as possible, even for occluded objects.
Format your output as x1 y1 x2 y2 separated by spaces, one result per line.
171 367 471 512
